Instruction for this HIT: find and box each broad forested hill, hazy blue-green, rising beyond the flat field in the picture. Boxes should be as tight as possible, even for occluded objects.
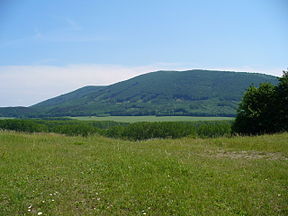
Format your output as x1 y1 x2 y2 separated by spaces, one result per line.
0 70 278 116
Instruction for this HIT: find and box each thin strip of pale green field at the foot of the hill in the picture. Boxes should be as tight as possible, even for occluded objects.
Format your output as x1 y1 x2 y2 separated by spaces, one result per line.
71 116 234 123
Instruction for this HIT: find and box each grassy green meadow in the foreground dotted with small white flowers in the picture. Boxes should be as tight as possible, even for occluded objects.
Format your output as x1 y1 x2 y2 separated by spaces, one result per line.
0 132 288 216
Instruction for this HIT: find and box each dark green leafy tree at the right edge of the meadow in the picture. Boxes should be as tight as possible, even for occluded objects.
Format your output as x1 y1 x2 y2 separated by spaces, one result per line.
233 71 288 134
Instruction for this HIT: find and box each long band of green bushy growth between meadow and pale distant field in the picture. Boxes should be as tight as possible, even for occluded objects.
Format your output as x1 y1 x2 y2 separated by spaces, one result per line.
0 118 232 140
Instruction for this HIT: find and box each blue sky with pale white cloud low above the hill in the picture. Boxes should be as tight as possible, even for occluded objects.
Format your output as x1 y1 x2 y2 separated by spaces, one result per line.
0 0 288 107
